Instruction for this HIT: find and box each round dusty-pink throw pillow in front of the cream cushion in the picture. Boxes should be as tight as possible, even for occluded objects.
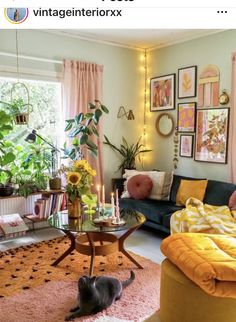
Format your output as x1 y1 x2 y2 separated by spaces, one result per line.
127 174 153 200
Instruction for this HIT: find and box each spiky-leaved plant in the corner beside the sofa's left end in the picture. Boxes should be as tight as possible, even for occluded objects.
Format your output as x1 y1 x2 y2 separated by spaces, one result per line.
103 135 152 173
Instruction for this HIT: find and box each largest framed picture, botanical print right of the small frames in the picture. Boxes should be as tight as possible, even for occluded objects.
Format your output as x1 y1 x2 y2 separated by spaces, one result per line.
195 108 229 163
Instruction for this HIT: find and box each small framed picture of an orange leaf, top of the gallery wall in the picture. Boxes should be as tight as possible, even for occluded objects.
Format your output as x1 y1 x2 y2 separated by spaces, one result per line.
178 66 197 98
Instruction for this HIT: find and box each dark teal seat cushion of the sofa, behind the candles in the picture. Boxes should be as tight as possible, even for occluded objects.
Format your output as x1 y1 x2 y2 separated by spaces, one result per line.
120 198 182 224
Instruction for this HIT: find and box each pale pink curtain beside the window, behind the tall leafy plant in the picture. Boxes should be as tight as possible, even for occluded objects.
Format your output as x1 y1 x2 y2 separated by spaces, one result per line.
62 60 103 184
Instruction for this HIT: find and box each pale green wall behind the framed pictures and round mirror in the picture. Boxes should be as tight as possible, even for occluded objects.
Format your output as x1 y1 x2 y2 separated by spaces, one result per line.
148 30 236 181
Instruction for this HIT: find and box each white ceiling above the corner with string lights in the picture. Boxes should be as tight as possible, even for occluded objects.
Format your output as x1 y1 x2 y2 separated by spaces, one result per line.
51 29 222 49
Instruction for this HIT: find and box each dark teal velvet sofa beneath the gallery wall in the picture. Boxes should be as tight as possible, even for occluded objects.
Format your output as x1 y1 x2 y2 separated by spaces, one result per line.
116 175 236 233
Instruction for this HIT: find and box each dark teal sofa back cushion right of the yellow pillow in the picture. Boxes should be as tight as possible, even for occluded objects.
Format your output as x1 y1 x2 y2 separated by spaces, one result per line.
203 180 236 206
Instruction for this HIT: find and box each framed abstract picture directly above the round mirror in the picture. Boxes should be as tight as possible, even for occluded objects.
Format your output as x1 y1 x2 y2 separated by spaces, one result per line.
150 74 175 112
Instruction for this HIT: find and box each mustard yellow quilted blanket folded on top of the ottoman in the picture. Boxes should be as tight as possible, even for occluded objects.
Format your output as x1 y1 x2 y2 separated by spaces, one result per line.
161 233 236 298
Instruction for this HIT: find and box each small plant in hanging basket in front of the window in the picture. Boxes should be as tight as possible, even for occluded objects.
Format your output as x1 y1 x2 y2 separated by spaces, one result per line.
0 98 33 125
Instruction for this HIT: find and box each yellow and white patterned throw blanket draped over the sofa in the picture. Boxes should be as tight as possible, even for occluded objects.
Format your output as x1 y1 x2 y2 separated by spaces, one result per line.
170 198 236 235
